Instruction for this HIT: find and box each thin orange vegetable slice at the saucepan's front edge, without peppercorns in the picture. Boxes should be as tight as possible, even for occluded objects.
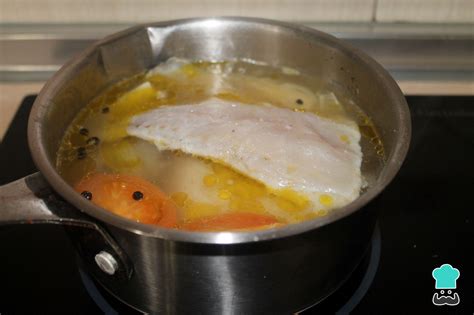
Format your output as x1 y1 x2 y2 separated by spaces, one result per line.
180 212 280 231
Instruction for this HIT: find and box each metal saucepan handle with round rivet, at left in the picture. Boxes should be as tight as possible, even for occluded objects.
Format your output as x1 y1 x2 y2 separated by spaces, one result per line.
0 173 132 281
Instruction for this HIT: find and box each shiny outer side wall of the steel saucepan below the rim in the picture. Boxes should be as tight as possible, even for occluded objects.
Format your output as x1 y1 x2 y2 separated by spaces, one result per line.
96 204 376 314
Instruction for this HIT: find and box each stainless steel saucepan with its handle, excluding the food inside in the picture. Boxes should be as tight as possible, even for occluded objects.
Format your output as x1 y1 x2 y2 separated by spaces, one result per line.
0 18 411 314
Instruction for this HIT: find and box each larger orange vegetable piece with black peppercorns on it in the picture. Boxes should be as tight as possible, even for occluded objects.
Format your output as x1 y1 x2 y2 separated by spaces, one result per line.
75 173 177 228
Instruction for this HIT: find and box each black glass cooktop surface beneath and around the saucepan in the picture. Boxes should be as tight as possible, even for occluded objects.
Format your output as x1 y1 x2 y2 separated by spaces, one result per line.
0 96 474 315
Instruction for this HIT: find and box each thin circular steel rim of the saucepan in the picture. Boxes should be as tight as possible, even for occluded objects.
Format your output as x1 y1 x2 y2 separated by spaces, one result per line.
28 17 411 244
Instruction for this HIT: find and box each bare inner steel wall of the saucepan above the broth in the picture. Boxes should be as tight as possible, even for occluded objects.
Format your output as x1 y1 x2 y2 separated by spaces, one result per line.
29 18 410 242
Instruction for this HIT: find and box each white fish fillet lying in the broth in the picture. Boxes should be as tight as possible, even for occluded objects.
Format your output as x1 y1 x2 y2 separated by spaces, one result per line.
127 99 362 207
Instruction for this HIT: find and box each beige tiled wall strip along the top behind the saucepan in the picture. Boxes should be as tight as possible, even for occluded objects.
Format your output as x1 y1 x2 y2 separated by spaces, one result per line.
0 0 474 24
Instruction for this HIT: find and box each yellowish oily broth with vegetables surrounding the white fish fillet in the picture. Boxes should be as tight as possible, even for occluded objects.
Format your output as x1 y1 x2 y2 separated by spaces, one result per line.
57 58 383 231
